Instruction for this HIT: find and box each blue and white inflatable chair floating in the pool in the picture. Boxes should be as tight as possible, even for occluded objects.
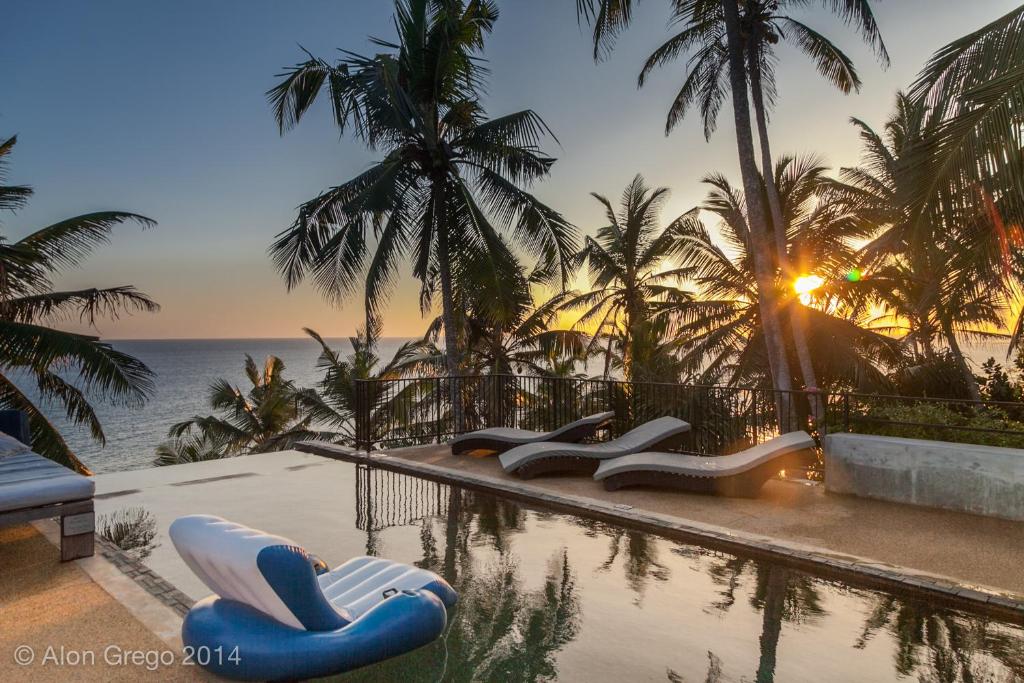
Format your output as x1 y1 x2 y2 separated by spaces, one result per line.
170 515 457 680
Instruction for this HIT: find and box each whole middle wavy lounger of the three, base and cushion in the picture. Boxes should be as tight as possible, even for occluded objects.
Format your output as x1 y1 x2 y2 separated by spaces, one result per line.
501 417 690 479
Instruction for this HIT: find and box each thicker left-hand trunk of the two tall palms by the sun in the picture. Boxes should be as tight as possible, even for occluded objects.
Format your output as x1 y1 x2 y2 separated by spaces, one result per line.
722 0 793 411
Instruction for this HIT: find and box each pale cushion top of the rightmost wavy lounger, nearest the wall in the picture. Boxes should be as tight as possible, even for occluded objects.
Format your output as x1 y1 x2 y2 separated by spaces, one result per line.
594 431 815 480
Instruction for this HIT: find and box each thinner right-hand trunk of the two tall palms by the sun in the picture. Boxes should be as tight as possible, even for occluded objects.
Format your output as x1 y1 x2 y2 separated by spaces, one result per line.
746 42 823 424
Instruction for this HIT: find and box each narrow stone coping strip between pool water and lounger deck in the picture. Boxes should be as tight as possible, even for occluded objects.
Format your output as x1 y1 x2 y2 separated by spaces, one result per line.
296 442 1024 626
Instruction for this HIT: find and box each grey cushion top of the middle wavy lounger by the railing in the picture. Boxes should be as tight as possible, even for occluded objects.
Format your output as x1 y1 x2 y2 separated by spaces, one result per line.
500 417 690 472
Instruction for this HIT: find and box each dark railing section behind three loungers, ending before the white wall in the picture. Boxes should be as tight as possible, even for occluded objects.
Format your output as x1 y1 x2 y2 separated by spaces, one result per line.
355 375 828 455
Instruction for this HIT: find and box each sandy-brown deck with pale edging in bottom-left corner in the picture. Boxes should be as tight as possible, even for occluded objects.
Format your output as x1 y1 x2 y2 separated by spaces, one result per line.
0 520 201 681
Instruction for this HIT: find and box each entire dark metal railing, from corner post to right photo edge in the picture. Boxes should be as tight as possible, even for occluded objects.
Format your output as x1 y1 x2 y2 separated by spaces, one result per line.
346 375 1024 456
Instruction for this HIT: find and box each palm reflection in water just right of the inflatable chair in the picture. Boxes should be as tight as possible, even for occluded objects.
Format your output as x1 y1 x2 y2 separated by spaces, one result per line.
339 487 580 681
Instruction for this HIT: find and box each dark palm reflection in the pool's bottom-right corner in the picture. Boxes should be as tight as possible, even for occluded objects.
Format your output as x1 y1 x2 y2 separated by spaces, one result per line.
854 596 1024 683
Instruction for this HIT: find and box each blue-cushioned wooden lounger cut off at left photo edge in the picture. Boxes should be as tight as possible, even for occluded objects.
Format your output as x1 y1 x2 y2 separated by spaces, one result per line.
0 434 96 561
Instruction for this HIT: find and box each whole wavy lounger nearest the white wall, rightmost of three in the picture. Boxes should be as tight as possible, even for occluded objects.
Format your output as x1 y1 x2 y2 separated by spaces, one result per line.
594 431 816 498
